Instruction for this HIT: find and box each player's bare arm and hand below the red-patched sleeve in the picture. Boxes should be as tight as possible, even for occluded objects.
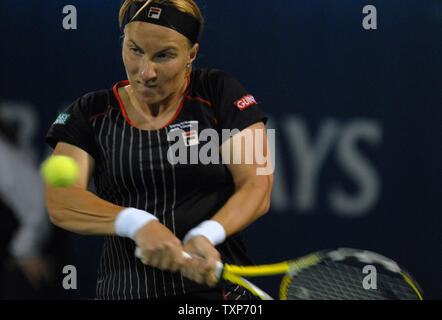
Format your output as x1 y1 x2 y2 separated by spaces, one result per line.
182 122 273 286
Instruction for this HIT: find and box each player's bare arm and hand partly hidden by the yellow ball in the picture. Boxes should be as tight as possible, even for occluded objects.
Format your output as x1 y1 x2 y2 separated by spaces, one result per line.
46 142 186 271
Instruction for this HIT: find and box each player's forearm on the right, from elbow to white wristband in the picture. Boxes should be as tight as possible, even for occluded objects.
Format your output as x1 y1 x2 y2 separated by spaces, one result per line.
212 181 271 236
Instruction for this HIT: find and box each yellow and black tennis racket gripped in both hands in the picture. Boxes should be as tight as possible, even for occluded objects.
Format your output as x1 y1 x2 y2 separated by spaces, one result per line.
135 248 423 300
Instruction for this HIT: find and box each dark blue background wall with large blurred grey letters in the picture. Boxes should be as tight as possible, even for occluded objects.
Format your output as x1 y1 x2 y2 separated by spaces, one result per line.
0 0 442 299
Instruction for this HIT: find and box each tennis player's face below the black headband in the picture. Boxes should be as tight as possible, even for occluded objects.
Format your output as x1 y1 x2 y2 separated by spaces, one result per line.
123 22 198 104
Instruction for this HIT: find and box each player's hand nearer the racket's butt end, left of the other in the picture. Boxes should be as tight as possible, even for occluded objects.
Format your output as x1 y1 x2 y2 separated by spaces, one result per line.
135 221 189 272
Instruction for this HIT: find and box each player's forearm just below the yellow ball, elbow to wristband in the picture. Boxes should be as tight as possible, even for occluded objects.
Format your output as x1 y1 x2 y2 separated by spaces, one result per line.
46 186 124 235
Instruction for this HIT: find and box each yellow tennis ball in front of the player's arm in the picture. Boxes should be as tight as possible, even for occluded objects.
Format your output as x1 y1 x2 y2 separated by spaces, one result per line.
41 155 80 188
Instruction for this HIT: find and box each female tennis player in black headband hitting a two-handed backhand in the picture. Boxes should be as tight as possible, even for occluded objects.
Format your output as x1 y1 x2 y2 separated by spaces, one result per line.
46 0 273 299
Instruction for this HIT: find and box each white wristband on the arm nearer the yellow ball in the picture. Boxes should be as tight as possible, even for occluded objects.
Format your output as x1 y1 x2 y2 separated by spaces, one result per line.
115 208 158 240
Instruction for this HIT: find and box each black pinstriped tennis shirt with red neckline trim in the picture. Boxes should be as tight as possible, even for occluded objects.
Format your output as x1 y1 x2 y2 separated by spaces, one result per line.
46 68 266 299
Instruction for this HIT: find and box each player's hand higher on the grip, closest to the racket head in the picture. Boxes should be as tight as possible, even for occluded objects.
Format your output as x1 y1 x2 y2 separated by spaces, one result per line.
181 236 221 287
